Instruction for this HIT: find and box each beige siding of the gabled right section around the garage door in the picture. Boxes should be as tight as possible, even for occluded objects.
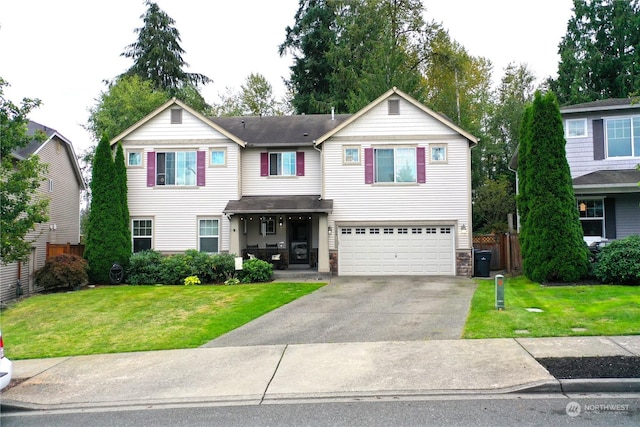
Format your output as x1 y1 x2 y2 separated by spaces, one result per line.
322 100 471 249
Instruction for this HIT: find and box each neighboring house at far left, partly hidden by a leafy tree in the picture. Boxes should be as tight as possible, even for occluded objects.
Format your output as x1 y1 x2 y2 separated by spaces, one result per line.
0 121 86 301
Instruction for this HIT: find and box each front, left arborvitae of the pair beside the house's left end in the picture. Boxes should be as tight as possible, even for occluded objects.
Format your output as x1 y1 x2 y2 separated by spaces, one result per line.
84 136 131 283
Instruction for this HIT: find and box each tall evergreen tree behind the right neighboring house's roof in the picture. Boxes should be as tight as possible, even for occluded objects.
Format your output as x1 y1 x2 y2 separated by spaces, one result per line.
549 0 640 104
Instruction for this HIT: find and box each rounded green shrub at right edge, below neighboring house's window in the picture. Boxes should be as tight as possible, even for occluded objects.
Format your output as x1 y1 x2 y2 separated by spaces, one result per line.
595 235 640 285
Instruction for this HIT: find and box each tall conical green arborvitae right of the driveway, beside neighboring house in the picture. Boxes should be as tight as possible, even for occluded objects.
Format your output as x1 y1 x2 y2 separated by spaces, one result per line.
519 92 589 282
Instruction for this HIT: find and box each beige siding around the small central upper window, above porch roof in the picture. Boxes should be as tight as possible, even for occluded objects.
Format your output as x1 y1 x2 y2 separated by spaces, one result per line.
242 147 322 196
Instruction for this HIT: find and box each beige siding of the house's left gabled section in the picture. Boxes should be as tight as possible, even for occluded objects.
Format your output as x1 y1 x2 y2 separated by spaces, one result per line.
123 140 240 253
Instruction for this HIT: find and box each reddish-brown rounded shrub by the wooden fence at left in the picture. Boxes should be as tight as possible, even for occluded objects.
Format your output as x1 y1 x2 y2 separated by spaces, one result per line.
35 254 89 289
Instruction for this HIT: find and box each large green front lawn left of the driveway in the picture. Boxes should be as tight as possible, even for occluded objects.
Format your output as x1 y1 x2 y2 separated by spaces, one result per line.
0 283 324 359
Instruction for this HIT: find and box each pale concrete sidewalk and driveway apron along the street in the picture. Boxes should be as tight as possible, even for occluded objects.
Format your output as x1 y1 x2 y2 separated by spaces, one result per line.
1 336 640 409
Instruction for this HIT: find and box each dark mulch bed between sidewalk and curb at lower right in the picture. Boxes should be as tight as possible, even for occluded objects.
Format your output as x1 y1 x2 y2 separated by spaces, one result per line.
536 356 640 379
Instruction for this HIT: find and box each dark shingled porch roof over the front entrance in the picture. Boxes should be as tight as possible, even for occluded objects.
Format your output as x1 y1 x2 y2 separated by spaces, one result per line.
223 195 333 215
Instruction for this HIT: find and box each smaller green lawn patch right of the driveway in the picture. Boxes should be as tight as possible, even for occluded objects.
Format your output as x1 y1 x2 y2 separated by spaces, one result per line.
463 277 640 338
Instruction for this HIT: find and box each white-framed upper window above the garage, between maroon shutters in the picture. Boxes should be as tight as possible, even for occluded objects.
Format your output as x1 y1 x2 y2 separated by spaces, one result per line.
374 147 417 182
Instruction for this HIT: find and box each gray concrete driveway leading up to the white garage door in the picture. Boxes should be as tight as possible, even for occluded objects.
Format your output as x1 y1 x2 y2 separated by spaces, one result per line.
203 276 476 347
